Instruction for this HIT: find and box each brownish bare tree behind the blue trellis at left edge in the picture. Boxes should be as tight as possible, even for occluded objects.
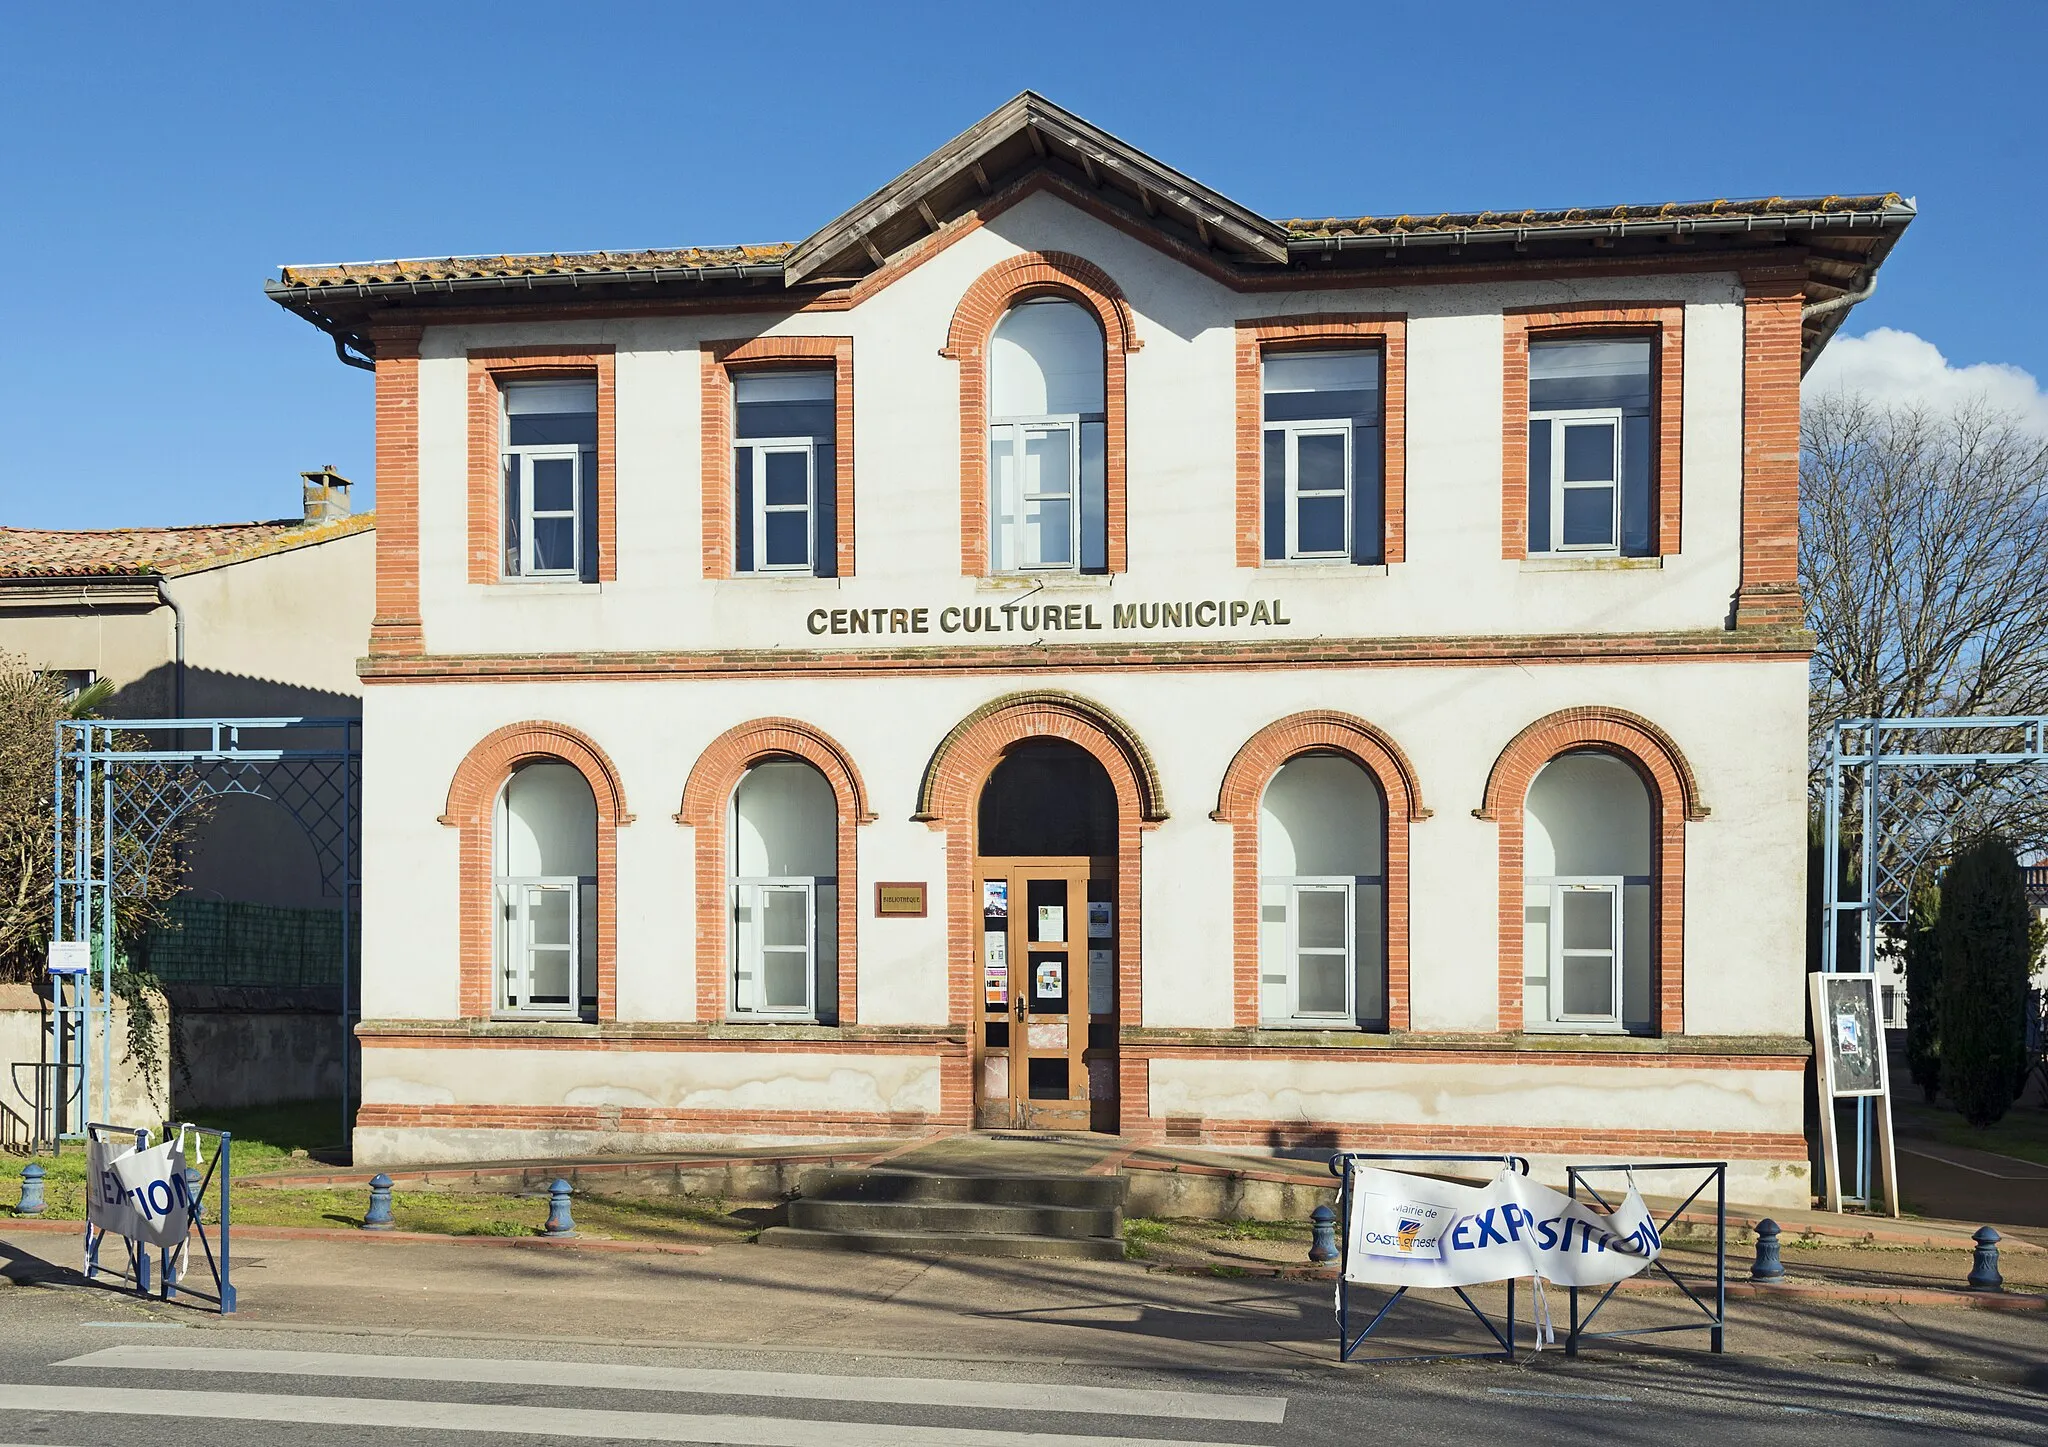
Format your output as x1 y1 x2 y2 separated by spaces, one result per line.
0 653 205 980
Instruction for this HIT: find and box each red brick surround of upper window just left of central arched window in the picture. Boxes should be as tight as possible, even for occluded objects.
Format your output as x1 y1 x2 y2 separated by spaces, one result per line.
700 336 854 577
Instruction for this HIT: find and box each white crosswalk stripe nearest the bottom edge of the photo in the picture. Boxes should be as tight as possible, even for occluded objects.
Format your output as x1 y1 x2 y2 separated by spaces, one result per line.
0 1384 1277 1447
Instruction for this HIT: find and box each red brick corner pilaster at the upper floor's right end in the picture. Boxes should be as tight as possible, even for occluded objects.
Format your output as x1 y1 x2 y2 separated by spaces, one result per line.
1736 278 1806 628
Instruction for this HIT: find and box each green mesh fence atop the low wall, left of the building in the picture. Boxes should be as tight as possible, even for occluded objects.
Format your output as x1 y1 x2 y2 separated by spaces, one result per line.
145 898 362 989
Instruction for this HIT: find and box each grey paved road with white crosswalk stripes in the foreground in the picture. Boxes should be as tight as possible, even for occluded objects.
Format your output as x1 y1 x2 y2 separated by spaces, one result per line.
0 1289 2048 1447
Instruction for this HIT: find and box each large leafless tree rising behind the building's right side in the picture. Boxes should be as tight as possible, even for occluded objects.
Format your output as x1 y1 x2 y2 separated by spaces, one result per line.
1800 393 2048 847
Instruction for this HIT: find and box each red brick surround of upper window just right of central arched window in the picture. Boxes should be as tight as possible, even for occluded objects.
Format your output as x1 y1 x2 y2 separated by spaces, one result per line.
1237 311 1407 567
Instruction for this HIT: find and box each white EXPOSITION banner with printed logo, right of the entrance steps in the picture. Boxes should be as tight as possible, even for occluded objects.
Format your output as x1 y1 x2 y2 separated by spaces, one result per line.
1343 1165 1663 1287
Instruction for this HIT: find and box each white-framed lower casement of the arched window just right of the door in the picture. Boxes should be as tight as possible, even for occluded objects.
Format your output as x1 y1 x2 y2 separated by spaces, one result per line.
1260 874 1384 1029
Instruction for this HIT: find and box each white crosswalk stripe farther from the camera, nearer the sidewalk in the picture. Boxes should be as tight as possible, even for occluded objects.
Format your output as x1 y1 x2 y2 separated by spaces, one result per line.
57 1345 1286 1422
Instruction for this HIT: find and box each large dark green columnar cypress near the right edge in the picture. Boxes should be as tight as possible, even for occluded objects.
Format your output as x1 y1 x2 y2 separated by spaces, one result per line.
1933 837 2032 1128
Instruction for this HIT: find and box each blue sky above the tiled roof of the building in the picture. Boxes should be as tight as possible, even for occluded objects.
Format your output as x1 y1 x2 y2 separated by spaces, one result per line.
0 0 2048 528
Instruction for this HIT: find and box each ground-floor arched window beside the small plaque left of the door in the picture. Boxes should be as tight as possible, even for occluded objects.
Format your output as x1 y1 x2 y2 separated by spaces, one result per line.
727 759 840 1021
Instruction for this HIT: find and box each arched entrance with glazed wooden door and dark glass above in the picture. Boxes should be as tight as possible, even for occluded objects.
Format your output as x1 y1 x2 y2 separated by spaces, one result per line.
975 739 1118 1132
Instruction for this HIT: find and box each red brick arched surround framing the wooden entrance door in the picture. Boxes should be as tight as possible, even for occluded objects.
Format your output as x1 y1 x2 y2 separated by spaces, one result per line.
918 694 1165 1117
